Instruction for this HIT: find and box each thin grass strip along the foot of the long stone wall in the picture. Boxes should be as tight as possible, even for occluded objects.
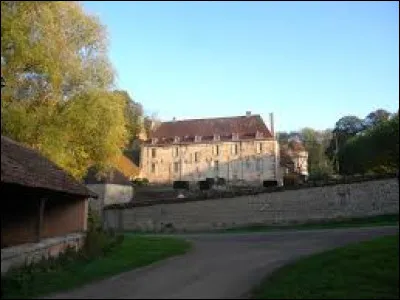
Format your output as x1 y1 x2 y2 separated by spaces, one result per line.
217 214 399 233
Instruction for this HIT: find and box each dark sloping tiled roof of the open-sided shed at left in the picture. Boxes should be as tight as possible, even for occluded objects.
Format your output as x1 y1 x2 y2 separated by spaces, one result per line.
1 136 97 197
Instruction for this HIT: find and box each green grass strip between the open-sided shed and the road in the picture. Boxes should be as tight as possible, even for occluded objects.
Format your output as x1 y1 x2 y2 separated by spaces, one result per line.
1 236 191 299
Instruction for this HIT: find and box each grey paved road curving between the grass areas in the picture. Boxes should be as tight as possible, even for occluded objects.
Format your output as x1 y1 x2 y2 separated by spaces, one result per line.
47 227 398 299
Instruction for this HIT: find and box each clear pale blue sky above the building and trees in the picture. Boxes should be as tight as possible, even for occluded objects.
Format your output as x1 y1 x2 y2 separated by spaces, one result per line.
83 1 399 131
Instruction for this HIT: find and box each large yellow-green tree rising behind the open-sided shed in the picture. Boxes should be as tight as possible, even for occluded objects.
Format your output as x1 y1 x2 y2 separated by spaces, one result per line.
1 1 127 178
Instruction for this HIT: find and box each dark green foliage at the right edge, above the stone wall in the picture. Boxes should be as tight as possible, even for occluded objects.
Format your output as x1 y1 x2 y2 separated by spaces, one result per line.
339 115 399 174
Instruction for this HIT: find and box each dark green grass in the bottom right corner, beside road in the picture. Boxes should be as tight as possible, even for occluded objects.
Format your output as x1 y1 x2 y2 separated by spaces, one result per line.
252 234 399 299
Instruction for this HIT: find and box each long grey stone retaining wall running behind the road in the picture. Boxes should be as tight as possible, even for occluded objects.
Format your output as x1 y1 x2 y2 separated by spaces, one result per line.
103 178 399 231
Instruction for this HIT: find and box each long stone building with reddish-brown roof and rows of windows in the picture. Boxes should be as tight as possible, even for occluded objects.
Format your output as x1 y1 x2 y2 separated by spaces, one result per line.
140 112 282 183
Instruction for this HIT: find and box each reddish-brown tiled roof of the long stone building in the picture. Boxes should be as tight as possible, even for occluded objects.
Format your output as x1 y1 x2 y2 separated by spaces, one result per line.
151 115 272 142
